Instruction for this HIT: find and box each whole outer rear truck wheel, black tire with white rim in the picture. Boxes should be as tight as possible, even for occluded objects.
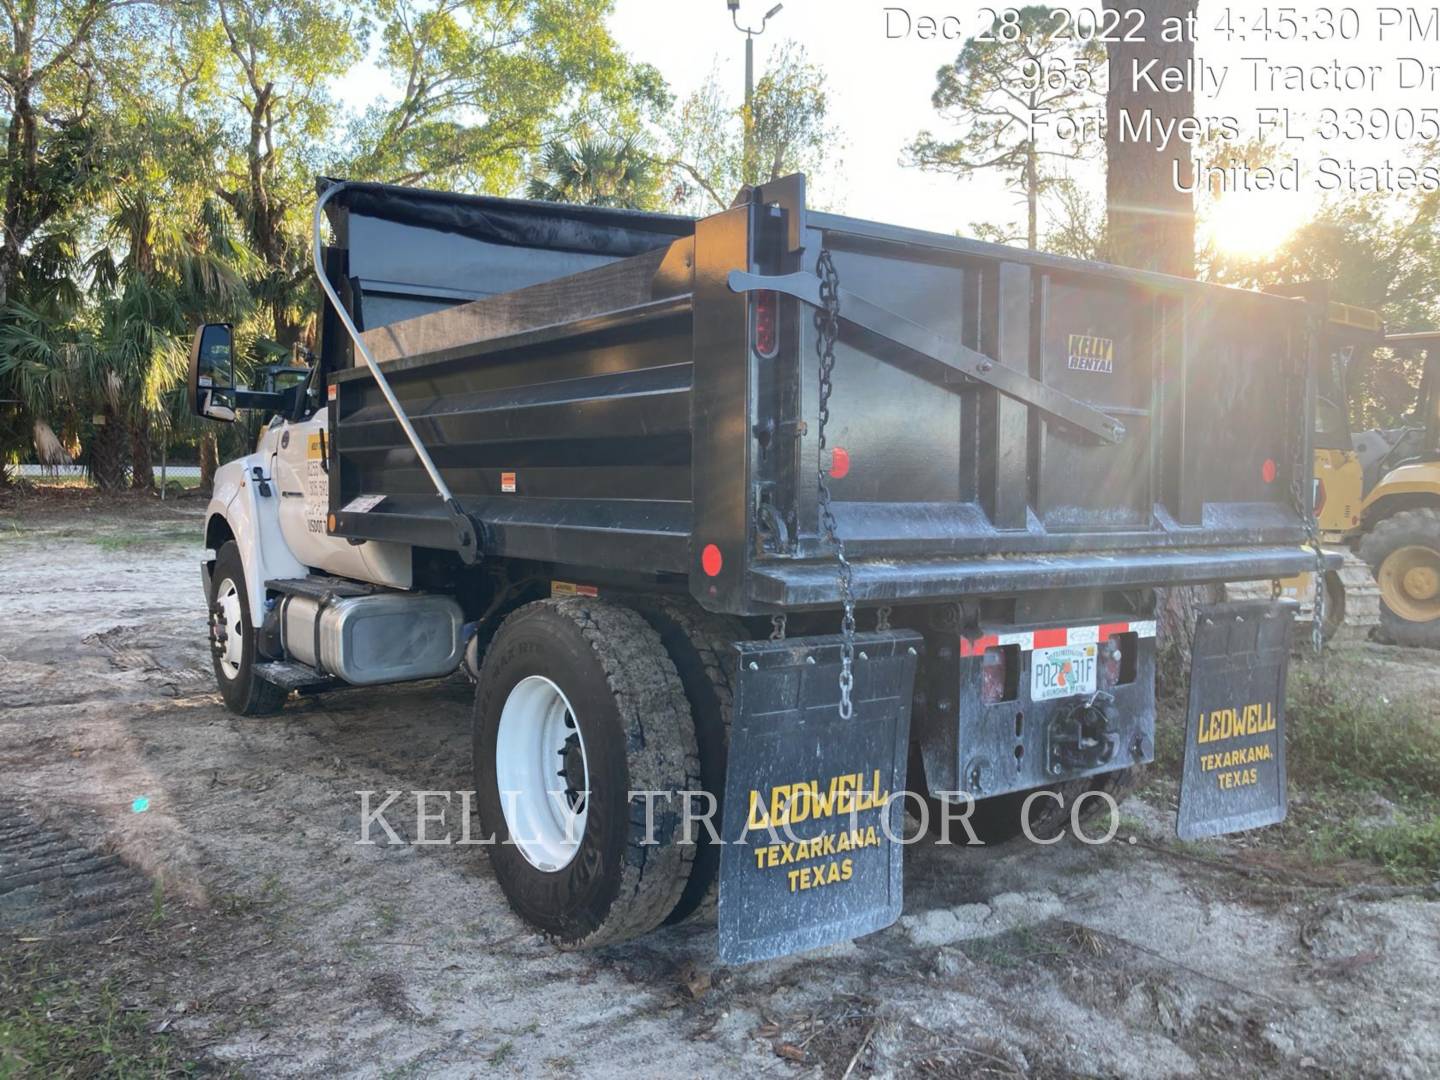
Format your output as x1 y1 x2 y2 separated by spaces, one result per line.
474 598 701 948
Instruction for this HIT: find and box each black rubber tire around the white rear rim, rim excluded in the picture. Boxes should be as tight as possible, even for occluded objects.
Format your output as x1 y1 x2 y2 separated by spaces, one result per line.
474 598 701 949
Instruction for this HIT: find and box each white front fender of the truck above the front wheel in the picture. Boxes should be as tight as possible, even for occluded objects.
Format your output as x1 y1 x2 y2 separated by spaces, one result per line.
204 454 308 625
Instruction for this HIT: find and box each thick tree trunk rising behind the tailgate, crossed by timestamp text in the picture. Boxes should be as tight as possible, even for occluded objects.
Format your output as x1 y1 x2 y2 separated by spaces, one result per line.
1104 0 1198 278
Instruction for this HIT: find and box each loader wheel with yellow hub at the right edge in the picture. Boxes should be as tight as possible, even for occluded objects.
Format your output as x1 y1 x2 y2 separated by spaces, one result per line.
1359 510 1440 648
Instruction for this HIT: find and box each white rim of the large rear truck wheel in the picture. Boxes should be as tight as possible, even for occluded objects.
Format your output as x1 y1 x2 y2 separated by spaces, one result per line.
495 675 590 874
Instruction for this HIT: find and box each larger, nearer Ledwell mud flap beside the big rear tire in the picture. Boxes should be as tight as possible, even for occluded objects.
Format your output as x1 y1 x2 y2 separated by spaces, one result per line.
720 631 923 963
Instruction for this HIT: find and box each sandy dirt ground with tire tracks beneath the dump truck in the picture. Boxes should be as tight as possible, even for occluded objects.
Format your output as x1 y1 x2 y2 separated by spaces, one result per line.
0 500 1440 1077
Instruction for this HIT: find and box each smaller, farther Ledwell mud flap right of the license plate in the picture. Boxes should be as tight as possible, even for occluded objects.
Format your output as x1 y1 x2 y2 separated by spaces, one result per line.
1175 600 1295 840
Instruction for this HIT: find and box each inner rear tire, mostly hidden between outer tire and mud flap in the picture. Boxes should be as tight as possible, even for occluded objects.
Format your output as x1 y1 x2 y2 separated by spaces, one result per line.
635 598 749 923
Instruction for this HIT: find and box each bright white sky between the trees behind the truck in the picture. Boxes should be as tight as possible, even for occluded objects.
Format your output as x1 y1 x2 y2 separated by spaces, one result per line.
611 0 1440 252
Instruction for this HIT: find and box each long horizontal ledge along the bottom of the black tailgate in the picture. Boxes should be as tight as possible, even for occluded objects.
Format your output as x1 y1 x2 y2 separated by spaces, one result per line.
752 544 1342 608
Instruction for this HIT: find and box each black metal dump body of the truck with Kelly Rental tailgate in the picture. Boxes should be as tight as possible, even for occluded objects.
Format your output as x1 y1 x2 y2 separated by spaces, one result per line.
321 177 1323 615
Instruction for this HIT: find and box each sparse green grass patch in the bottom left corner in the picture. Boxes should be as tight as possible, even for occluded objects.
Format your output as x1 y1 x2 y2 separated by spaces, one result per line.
0 959 199 1080
